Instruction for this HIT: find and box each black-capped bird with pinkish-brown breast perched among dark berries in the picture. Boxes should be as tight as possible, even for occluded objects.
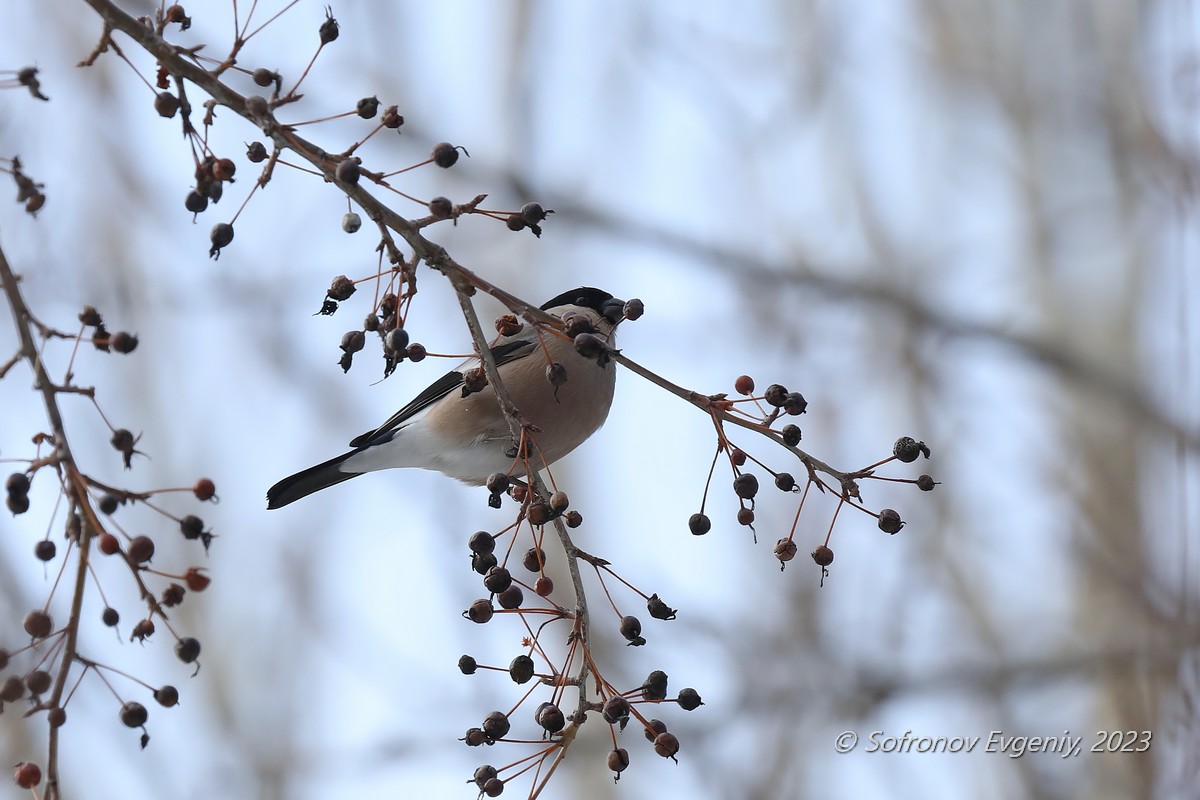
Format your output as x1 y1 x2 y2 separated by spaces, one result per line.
266 287 625 509
